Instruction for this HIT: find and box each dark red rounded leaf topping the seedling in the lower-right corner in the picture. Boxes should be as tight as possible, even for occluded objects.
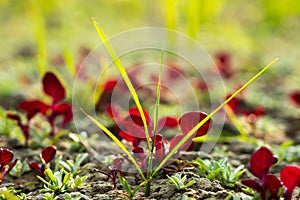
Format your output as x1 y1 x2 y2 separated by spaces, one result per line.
250 147 278 179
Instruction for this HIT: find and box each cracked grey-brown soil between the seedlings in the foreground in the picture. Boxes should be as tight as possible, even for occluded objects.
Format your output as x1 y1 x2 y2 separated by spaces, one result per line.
0 134 300 200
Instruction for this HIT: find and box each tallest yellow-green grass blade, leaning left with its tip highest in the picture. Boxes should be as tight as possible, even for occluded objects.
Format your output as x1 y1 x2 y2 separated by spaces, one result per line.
92 18 151 151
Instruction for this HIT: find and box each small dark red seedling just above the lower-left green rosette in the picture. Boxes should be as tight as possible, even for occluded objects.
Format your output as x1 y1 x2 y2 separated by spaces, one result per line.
28 146 56 177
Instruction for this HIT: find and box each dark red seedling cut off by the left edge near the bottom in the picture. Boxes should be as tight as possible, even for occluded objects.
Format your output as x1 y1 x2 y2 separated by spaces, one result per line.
0 148 18 185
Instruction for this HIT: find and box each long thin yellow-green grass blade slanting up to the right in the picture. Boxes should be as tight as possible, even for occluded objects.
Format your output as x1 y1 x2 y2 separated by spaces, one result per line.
152 58 279 177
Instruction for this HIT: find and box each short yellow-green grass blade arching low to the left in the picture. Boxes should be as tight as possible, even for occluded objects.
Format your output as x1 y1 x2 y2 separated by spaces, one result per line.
81 110 146 180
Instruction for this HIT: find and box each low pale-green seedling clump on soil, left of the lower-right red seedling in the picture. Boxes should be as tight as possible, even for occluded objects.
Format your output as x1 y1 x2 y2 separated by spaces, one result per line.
194 158 245 188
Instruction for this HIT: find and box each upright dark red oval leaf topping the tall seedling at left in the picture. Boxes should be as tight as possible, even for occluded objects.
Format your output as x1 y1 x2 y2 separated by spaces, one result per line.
43 72 65 104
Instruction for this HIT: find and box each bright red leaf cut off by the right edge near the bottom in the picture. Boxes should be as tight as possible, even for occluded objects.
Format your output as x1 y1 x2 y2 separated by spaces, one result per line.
280 166 300 191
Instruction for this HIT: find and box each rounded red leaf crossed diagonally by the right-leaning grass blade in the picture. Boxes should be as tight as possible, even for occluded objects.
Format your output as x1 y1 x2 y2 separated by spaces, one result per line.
179 112 212 137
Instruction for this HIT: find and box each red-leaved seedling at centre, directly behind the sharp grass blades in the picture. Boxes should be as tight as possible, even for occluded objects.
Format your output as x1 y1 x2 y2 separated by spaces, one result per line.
119 108 212 170
